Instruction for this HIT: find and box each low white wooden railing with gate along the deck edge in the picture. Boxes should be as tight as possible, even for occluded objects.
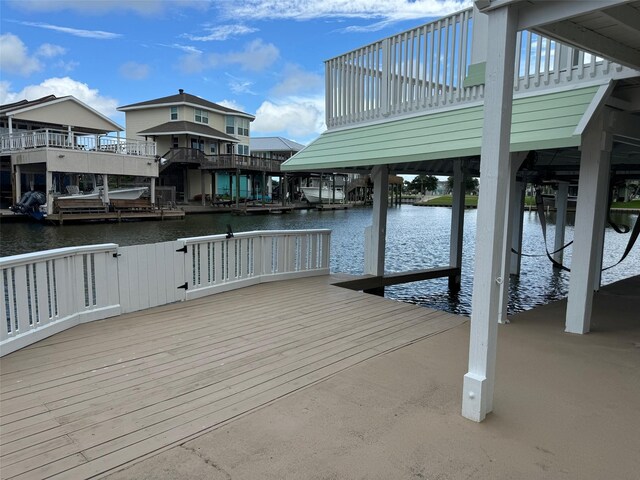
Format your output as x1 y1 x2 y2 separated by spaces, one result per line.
0 230 331 355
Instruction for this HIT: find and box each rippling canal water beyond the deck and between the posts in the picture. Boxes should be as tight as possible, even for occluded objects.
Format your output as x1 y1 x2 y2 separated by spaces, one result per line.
0 205 640 314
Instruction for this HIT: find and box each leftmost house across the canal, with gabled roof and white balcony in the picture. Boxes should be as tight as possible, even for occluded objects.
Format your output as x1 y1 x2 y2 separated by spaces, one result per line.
0 95 158 213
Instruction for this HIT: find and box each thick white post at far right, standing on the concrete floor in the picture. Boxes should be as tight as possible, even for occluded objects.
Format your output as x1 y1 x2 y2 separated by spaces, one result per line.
565 110 612 334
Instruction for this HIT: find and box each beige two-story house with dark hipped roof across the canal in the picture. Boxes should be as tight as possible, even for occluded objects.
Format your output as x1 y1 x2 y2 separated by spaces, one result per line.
118 89 270 202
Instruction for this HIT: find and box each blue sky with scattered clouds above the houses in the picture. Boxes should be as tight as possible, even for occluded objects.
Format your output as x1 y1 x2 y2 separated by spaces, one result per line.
0 0 471 144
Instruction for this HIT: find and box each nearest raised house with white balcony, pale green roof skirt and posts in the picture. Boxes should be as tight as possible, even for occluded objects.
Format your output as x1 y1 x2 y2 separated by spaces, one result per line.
282 0 640 421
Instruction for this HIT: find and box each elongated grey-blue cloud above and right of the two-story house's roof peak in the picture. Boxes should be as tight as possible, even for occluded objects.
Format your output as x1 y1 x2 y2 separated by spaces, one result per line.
178 39 280 73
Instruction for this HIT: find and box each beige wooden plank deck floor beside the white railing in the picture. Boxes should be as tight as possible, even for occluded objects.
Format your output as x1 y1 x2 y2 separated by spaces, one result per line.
0 276 466 479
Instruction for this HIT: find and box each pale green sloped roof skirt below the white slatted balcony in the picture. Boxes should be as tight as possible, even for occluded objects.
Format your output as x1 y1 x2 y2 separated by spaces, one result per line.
281 85 601 171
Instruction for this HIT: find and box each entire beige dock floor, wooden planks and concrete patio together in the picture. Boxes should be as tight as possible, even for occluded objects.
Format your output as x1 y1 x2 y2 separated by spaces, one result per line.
0 275 640 480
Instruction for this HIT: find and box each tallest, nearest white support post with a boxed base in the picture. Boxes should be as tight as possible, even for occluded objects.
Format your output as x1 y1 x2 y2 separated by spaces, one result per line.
462 4 518 422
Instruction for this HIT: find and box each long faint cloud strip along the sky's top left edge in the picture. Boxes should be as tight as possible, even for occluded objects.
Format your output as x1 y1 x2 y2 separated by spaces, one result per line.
7 0 210 16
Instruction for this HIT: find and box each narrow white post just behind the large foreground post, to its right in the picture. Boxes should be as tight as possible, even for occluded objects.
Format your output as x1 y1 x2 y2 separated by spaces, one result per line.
498 152 525 324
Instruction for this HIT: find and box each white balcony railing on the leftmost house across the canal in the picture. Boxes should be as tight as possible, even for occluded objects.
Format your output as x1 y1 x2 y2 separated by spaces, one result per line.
0 128 156 157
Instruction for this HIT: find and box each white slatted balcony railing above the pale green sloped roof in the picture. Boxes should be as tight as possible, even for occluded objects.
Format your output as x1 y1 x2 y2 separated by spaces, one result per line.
325 9 623 129
